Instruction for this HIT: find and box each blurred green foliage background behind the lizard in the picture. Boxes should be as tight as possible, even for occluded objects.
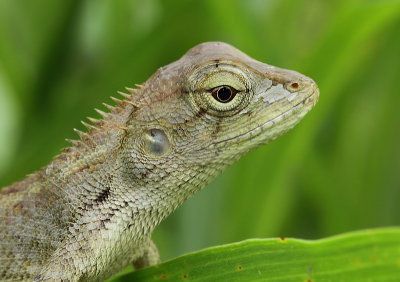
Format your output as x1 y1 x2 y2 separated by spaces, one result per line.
0 0 400 259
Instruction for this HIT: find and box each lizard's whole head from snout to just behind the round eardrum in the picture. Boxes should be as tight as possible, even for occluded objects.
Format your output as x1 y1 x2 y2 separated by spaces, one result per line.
117 42 319 205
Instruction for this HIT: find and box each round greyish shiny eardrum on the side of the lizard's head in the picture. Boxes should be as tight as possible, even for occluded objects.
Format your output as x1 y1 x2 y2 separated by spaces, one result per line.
143 128 171 157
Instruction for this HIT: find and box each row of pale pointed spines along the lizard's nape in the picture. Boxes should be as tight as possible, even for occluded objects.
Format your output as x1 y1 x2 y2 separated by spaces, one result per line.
64 84 144 152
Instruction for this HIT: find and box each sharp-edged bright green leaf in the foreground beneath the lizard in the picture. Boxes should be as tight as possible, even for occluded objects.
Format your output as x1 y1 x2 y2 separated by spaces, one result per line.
114 228 400 281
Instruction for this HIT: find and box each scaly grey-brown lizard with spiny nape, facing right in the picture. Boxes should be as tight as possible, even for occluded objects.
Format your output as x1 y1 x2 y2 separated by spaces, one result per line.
0 42 319 281
